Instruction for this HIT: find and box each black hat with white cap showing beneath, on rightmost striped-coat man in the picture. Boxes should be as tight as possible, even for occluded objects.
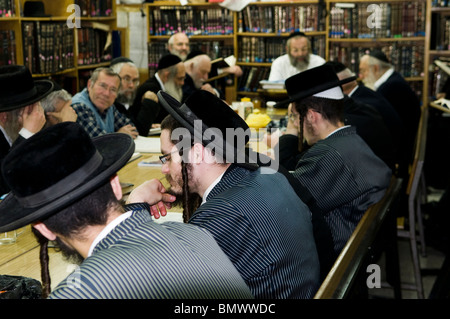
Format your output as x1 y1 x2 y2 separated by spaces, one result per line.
275 64 356 107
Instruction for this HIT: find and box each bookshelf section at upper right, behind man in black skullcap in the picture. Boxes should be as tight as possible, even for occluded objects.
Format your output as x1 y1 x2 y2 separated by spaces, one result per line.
327 0 429 105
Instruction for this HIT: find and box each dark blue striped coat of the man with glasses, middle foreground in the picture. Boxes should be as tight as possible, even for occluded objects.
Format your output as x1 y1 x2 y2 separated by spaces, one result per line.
189 165 319 299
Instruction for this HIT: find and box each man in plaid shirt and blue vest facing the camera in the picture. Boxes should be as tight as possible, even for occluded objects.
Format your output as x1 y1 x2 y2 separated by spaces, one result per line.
72 67 138 138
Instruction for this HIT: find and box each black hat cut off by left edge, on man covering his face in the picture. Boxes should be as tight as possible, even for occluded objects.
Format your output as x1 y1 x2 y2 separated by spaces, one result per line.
0 65 53 112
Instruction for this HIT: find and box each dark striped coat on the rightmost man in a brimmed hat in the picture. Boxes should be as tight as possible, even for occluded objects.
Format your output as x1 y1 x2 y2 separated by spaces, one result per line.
293 126 392 254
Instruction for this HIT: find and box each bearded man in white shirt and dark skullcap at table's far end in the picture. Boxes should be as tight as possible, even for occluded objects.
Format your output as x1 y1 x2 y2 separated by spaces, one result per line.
269 32 325 81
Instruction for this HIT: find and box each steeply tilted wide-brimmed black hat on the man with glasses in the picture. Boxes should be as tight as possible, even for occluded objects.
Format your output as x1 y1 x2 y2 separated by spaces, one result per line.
157 90 253 164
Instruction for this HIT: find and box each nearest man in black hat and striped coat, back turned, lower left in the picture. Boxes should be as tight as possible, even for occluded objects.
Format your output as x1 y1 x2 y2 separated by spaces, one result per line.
0 122 252 299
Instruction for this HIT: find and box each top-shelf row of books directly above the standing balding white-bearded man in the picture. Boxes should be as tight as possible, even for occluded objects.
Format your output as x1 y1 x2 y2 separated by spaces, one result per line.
148 6 233 35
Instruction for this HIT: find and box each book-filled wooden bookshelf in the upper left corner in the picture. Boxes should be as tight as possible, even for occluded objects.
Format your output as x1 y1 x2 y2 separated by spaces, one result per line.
0 0 116 94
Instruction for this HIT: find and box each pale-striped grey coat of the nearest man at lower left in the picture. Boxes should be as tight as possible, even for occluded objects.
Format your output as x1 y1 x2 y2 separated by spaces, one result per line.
50 205 253 299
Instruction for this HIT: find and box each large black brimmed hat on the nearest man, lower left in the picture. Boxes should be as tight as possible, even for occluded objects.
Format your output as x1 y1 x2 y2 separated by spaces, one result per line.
0 122 135 232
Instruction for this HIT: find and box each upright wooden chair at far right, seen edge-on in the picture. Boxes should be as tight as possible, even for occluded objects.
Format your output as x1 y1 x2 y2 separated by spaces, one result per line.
397 107 428 299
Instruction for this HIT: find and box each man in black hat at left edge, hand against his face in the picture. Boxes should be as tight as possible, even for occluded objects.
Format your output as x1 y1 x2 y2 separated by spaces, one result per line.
0 65 53 194
